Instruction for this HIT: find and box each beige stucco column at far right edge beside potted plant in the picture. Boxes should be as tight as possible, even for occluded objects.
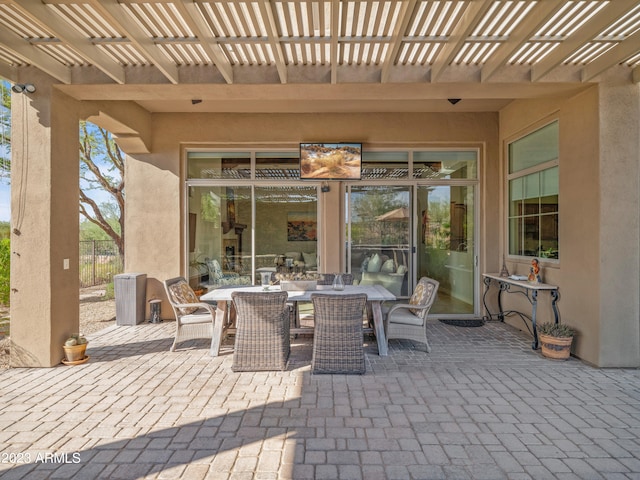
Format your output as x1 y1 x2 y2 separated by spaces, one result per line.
600 75 640 367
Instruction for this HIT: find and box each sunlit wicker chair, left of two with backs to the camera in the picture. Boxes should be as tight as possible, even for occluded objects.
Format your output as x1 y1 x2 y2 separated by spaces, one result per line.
231 292 291 372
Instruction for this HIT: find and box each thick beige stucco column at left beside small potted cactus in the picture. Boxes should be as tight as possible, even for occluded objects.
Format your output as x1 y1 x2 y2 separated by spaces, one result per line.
10 69 79 367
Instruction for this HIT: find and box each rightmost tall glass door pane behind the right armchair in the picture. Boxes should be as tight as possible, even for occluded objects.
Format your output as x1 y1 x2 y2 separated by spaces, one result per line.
416 185 476 314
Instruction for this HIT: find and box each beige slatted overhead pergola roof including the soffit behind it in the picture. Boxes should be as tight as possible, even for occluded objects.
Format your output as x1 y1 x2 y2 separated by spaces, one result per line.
0 0 640 112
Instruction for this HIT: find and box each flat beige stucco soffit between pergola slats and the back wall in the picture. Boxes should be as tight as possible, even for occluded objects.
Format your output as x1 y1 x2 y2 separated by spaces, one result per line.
57 79 586 113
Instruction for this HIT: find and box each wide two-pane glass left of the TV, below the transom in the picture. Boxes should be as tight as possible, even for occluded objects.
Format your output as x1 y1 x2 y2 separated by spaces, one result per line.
187 185 318 289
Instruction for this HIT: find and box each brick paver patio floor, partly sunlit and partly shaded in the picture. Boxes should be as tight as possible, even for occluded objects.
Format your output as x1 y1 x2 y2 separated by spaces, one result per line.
0 321 640 480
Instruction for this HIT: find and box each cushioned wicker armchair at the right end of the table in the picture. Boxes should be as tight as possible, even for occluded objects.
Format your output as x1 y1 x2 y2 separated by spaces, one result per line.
384 277 440 353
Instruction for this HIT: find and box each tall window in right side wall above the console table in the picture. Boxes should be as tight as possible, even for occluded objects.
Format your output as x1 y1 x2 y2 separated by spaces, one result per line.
508 121 559 259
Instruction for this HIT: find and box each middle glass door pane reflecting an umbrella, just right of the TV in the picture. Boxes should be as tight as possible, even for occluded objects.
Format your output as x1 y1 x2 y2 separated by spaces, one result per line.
347 186 411 297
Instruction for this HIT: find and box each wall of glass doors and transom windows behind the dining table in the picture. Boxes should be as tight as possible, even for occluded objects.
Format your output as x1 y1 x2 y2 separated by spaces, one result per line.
185 149 479 315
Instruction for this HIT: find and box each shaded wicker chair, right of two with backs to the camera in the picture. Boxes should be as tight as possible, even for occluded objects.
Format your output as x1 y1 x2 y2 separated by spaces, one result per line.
311 293 367 375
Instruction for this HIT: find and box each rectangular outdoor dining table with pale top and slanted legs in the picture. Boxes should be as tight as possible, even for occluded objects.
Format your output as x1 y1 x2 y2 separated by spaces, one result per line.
200 285 396 356
